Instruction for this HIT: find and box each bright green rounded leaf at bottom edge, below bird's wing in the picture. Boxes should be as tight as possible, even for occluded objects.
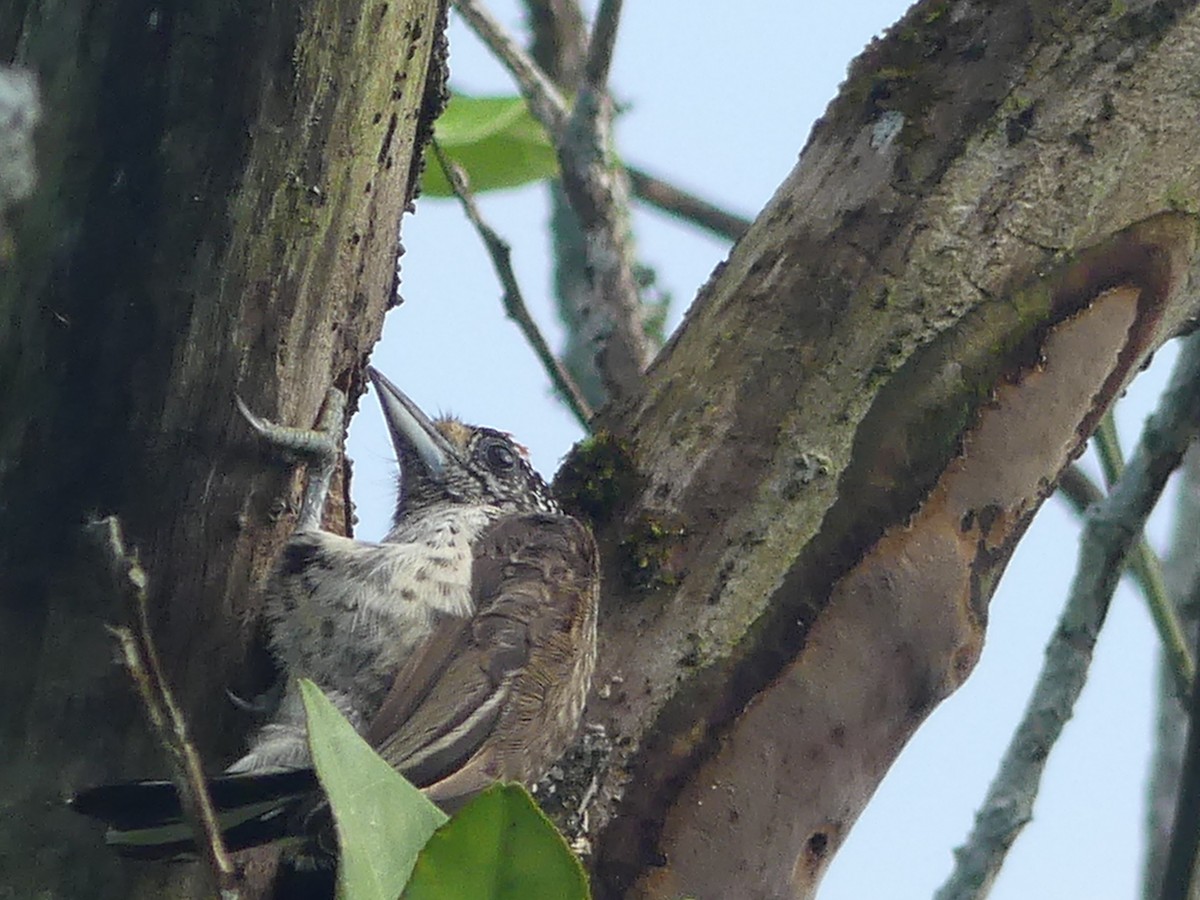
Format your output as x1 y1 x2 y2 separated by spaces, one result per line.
404 785 590 900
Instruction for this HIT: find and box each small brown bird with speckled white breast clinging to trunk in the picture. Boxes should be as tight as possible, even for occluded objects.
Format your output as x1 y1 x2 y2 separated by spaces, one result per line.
70 367 600 859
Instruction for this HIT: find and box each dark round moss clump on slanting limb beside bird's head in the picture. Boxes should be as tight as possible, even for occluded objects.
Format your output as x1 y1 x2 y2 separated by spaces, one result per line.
554 431 641 528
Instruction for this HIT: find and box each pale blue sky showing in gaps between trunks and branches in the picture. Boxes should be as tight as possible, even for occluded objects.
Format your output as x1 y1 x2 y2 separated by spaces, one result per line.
349 0 1174 900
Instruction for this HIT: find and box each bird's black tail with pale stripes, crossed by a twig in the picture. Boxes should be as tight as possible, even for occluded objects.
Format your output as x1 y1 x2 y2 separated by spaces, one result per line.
70 769 320 859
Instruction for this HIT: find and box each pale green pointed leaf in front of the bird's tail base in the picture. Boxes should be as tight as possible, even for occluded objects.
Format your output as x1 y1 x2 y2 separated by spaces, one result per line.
300 679 446 900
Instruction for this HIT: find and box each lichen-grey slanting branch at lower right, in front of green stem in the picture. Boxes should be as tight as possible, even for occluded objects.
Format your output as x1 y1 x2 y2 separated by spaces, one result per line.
935 335 1200 900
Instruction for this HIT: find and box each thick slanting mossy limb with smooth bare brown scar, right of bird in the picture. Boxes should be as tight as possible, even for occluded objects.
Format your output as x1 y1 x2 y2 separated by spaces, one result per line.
564 2 1200 898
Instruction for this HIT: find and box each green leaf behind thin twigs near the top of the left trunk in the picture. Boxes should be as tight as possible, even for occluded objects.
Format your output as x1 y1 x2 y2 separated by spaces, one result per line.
421 94 558 197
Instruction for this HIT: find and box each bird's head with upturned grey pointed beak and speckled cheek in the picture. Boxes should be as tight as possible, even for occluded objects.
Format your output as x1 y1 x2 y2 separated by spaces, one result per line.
367 367 558 523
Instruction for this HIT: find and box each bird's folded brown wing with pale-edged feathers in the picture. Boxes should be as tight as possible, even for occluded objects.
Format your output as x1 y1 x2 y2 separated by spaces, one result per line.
367 514 599 802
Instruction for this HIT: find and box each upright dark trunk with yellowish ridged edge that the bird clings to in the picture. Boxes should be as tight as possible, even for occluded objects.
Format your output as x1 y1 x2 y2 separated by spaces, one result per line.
0 0 444 898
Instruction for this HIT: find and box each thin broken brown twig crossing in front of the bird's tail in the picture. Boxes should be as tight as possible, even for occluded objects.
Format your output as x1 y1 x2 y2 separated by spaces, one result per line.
86 516 240 900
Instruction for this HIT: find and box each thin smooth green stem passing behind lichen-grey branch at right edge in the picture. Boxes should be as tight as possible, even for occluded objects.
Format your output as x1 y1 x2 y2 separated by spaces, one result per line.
1094 409 1195 704
